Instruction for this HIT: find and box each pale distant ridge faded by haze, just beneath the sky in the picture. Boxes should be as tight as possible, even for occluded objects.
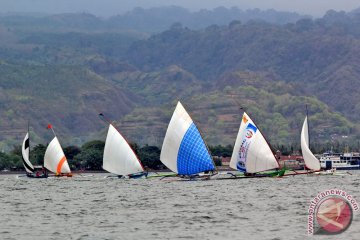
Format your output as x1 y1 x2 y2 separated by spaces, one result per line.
0 6 311 33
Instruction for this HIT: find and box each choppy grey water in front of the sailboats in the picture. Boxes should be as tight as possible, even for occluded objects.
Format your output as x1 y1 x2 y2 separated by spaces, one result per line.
0 173 360 240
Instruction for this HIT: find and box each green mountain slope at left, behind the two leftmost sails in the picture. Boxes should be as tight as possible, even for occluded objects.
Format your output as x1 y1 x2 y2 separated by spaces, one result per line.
0 63 133 150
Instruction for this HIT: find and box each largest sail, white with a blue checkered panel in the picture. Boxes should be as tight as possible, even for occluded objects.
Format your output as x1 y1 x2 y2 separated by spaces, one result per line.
160 102 215 175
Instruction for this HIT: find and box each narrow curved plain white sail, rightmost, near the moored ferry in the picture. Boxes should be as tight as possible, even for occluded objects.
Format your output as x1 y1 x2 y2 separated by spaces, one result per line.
301 117 320 171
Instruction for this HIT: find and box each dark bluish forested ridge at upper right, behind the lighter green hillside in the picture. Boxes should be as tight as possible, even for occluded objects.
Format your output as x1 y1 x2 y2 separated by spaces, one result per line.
126 11 360 121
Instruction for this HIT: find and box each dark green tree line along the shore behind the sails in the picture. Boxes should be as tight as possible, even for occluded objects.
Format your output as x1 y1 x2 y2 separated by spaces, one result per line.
0 140 360 171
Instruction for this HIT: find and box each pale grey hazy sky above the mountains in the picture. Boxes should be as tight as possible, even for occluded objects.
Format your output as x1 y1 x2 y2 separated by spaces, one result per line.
0 0 360 17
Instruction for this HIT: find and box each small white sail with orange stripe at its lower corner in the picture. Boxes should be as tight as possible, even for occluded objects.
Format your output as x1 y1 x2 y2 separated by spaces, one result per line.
44 137 71 174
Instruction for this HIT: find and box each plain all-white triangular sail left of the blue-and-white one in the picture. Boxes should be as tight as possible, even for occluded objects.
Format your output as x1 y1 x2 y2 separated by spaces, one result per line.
103 124 144 175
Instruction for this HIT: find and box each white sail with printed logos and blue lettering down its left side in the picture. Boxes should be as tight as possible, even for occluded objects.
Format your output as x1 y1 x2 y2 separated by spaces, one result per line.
230 112 279 173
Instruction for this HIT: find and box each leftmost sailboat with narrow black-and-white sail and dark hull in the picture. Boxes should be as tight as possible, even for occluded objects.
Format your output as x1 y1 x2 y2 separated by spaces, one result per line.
21 129 48 178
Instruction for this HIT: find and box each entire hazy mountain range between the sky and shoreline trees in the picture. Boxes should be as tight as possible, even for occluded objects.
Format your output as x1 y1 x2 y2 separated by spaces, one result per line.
0 8 360 150
